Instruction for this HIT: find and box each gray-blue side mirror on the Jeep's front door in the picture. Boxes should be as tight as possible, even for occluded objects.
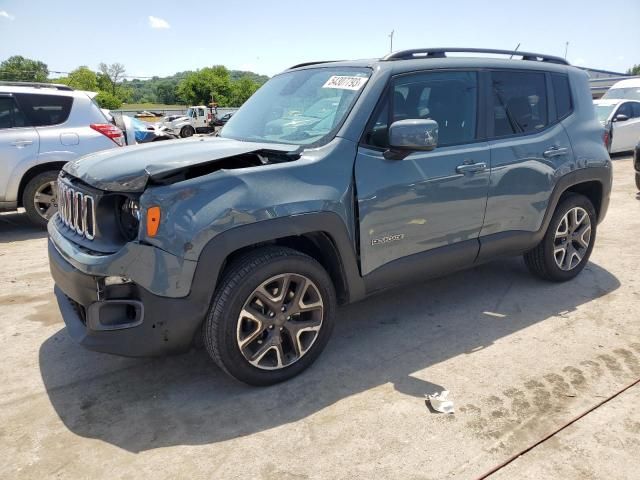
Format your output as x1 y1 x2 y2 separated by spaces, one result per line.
389 119 438 158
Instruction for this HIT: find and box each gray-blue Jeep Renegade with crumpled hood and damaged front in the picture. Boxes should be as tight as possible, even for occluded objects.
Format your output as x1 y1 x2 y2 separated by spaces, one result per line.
49 49 611 385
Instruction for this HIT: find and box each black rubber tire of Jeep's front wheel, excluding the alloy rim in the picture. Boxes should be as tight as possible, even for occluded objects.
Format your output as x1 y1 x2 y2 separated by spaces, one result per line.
203 246 336 386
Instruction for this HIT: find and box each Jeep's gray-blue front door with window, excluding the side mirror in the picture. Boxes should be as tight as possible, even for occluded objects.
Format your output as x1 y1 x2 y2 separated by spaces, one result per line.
355 71 490 277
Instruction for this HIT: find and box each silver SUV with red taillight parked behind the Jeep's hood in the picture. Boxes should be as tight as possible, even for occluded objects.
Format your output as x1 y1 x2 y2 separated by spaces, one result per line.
0 82 124 225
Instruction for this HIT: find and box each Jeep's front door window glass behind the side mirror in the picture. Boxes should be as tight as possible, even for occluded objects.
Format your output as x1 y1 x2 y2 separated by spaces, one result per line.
365 71 478 148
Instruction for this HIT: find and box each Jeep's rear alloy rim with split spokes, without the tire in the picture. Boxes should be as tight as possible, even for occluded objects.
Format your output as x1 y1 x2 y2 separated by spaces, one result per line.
553 207 591 271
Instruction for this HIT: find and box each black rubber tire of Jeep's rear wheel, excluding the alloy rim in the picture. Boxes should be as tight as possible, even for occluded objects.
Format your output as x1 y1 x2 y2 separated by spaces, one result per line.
524 193 598 282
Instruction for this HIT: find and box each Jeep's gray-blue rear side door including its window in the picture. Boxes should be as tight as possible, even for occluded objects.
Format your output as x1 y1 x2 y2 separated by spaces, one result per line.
480 69 573 255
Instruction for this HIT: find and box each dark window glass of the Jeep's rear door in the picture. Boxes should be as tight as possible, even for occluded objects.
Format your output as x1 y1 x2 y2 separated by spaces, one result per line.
491 71 549 137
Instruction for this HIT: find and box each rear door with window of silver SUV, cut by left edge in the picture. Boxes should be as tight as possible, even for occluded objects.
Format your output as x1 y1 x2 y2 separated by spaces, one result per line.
0 93 39 202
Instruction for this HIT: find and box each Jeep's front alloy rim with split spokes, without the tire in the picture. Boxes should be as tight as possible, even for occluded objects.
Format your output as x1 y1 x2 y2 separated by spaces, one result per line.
236 273 324 370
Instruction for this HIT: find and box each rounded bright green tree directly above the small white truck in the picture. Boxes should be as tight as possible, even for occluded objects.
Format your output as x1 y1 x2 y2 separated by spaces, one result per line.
177 65 232 107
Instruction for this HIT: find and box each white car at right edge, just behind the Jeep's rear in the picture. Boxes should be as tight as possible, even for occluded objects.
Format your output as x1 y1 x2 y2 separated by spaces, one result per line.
593 99 640 153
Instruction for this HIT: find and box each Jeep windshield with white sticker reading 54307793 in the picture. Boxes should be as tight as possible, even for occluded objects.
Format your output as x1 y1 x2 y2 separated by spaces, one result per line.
220 68 371 145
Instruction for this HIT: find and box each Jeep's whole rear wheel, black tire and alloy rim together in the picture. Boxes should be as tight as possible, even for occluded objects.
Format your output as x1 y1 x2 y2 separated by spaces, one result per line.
524 193 598 282
